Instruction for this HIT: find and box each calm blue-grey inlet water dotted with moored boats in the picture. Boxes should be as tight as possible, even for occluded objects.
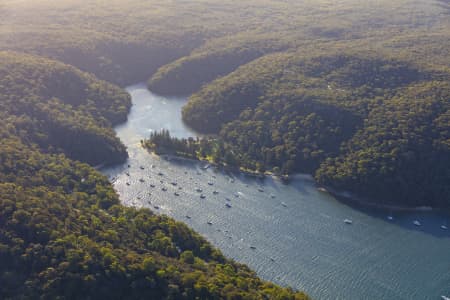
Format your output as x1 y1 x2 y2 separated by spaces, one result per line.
103 85 450 299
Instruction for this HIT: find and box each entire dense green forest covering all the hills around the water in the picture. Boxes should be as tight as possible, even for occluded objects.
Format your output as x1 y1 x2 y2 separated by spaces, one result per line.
0 0 450 299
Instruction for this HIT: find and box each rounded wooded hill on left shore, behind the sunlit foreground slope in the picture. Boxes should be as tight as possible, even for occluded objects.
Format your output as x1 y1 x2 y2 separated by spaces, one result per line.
0 52 131 165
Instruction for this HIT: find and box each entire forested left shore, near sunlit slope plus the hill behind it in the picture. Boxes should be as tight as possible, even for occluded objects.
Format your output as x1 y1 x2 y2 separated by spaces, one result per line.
0 52 307 299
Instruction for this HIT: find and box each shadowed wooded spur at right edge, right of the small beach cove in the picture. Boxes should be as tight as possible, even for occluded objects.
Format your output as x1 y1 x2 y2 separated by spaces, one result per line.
316 80 450 207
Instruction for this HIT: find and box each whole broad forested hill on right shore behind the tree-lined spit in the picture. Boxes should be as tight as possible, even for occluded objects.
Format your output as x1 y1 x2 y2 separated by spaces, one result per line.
183 52 450 207
